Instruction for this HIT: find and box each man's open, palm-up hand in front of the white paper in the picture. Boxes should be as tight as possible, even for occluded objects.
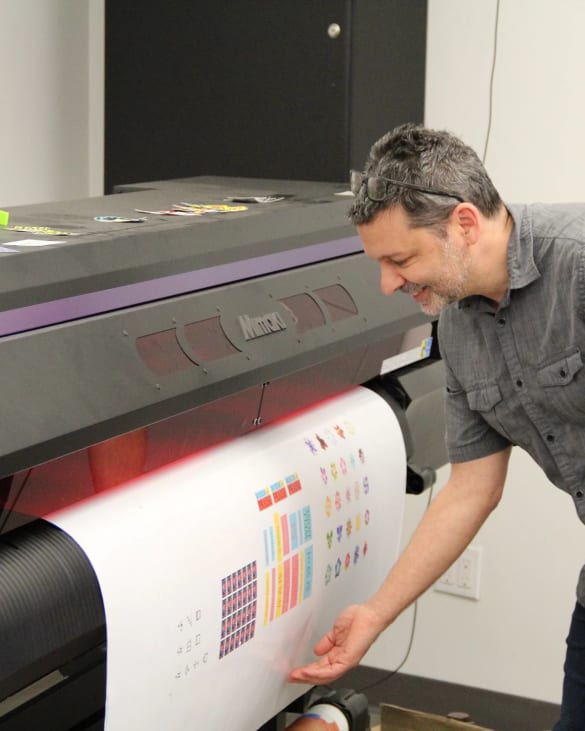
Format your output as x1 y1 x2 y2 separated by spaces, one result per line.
288 604 384 685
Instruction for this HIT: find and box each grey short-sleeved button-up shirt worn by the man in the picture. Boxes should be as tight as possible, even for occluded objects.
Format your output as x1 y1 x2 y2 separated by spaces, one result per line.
439 204 585 605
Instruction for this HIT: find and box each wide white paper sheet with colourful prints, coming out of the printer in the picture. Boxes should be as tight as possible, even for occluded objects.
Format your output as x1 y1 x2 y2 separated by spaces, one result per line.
47 388 406 731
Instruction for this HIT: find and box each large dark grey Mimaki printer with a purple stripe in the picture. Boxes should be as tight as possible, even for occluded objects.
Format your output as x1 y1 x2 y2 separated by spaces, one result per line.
0 177 445 731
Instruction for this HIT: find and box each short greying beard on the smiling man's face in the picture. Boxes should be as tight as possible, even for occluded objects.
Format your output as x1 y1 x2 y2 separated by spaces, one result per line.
400 239 469 315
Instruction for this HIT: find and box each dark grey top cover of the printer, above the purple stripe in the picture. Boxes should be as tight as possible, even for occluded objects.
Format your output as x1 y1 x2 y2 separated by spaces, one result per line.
0 177 361 312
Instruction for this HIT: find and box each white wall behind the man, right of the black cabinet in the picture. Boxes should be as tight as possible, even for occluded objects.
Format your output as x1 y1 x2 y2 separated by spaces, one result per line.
366 0 585 703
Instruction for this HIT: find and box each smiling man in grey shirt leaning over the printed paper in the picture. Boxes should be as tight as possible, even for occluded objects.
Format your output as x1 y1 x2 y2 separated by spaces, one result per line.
290 124 585 731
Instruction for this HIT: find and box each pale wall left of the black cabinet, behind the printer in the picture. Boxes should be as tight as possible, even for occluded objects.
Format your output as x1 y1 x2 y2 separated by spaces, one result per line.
0 0 104 208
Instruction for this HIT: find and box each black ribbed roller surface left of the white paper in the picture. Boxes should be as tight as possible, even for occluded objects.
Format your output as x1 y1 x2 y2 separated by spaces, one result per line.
0 520 105 700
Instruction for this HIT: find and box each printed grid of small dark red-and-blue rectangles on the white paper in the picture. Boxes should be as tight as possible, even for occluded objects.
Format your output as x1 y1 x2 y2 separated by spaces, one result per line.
219 561 258 659
